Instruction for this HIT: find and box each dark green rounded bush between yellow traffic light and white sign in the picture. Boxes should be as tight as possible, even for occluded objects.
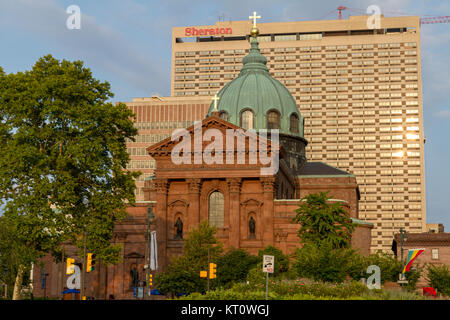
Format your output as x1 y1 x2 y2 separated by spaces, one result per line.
217 248 260 286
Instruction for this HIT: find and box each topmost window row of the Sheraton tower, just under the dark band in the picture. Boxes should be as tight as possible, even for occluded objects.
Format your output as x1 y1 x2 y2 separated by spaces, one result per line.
175 42 417 57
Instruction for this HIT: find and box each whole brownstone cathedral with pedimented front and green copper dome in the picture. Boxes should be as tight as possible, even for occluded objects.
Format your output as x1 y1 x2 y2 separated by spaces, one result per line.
35 23 373 299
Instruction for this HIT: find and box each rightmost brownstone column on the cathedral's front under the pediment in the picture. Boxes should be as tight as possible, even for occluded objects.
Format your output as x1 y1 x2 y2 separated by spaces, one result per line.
260 177 275 247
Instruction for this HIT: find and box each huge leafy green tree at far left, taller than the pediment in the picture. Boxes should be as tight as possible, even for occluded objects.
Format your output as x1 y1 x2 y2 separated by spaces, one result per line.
0 55 139 298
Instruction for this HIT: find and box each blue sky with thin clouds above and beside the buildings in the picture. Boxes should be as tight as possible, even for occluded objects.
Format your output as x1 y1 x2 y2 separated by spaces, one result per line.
0 0 450 232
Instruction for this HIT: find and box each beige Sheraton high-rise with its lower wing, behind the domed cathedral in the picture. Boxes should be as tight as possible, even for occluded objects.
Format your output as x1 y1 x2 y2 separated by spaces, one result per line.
127 16 426 251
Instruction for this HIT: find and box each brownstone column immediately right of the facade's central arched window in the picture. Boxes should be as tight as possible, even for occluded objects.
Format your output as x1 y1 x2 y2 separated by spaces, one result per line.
225 178 241 248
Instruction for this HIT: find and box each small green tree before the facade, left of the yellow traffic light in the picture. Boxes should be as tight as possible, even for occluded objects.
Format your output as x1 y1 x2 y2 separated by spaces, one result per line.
155 221 223 296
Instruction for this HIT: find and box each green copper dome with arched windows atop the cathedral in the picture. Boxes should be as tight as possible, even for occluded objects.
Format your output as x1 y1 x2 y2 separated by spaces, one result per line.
208 37 304 138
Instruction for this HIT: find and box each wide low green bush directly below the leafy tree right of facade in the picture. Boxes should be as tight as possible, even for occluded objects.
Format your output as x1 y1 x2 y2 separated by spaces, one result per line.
292 242 364 282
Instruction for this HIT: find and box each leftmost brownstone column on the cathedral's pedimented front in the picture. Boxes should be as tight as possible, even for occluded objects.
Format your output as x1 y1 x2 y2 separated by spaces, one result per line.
154 179 169 271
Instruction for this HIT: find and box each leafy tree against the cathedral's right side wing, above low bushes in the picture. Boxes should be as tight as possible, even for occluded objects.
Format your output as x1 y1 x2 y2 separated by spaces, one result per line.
293 192 355 248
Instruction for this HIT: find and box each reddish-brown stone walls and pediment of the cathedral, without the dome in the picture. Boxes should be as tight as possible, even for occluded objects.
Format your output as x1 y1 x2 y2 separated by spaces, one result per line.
34 116 373 299
